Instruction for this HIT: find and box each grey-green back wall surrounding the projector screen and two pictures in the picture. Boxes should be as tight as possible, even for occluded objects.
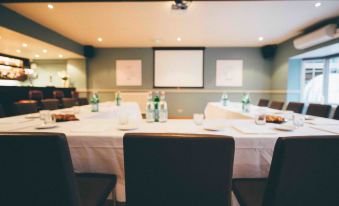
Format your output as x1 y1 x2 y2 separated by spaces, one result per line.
87 48 272 116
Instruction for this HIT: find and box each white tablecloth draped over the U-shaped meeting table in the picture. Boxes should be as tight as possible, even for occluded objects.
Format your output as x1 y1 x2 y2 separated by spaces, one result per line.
0 103 333 202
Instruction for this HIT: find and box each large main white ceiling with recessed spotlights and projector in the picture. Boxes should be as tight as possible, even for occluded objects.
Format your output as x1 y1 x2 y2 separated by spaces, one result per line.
4 1 339 47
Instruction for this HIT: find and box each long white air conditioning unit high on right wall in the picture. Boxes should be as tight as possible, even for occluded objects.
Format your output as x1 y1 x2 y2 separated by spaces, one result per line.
293 24 338 49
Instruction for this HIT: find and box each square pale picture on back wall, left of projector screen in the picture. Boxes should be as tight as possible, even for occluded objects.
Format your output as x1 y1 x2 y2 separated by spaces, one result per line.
115 60 142 86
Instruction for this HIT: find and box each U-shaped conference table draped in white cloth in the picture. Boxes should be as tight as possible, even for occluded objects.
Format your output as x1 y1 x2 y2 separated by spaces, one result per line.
0 102 339 202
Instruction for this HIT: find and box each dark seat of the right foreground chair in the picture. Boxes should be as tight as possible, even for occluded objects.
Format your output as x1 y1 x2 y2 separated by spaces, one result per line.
232 178 267 206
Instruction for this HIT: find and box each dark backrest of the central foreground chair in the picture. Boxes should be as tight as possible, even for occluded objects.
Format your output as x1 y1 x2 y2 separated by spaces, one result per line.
124 133 234 206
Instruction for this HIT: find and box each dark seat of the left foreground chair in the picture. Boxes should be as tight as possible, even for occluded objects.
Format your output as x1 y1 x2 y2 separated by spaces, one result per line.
76 173 116 206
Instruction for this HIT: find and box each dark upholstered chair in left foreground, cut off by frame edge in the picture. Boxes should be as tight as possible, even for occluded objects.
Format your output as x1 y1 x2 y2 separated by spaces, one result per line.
0 133 116 206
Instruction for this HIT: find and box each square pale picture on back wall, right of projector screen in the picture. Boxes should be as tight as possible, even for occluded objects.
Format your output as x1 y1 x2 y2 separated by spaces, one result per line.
215 60 243 87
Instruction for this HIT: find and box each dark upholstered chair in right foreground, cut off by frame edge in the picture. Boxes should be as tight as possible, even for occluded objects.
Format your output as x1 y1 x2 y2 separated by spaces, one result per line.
233 136 339 206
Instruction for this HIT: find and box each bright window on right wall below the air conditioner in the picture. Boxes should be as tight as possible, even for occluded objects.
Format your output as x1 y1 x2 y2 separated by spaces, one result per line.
301 57 339 104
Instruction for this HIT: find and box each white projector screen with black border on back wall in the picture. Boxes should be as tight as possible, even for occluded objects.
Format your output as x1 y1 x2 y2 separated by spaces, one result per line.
154 49 204 87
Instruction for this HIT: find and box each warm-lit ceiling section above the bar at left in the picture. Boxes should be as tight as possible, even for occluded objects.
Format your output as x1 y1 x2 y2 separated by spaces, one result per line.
0 27 83 59
